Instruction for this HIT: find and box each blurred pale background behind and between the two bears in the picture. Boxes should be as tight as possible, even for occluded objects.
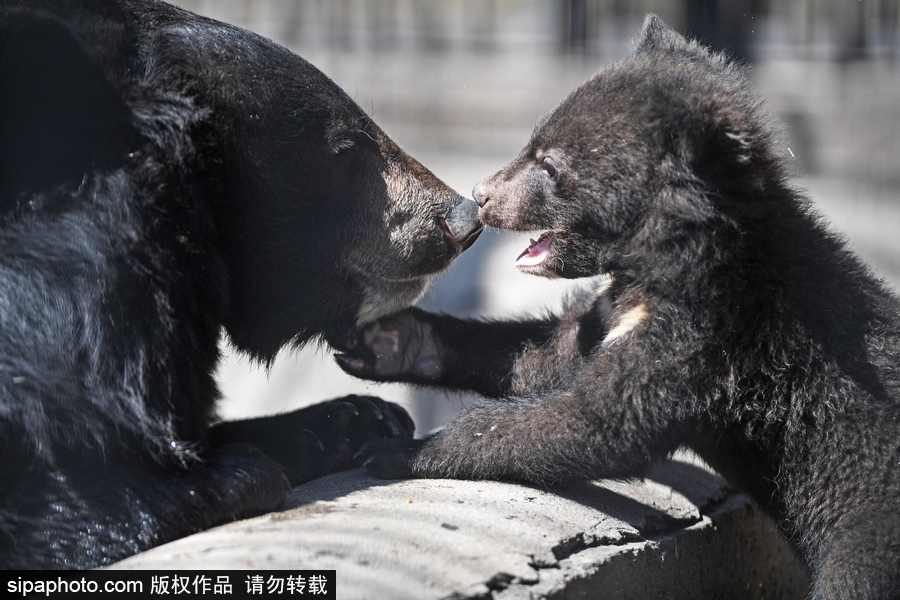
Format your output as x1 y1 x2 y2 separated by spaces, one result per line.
169 0 900 432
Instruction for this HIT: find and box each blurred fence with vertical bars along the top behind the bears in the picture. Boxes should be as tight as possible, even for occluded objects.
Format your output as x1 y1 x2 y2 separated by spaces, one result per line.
179 0 900 61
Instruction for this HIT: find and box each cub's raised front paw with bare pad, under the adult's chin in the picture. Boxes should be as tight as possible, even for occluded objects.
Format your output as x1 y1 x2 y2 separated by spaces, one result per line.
335 309 444 381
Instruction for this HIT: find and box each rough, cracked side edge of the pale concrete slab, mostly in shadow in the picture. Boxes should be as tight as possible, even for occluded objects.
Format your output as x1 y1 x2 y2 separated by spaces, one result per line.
488 493 809 600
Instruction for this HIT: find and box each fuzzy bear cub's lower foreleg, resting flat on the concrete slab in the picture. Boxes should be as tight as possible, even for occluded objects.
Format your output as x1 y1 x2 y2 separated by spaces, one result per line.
359 340 696 483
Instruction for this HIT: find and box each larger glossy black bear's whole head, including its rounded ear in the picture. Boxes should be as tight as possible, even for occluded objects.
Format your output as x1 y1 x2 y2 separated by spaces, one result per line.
0 0 481 359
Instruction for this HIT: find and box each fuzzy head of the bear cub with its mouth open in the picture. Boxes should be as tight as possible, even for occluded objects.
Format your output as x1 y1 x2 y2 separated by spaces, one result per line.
473 15 782 277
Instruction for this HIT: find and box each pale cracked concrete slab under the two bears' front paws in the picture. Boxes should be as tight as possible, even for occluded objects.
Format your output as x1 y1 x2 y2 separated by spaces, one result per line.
105 461 807 600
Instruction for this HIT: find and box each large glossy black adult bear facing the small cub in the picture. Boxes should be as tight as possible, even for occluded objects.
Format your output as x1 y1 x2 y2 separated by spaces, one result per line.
0 0 480 568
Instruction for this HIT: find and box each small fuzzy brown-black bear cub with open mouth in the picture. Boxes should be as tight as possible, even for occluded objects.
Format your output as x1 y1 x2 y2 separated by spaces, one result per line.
339 16 900 600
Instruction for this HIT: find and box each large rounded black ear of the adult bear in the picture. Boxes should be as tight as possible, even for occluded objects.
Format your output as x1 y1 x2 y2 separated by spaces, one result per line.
0 8 137 197
